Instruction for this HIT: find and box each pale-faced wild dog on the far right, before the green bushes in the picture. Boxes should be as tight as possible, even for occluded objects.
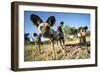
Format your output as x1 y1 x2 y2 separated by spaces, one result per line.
77 26 88 45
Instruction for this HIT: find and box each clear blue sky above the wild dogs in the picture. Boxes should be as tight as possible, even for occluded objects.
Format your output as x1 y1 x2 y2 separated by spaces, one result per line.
24 11 90 41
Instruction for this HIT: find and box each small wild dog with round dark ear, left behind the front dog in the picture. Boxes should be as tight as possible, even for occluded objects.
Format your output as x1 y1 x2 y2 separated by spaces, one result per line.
33 33 41 53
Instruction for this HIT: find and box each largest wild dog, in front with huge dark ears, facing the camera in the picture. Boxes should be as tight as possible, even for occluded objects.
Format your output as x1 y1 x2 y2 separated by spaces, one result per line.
30 14 65 59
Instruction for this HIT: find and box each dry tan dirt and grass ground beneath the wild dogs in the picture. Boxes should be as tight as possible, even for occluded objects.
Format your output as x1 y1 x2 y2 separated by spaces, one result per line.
24 36 90 61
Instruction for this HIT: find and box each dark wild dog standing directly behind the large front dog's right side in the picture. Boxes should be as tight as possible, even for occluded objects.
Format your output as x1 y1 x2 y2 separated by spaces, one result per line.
57 21 65 49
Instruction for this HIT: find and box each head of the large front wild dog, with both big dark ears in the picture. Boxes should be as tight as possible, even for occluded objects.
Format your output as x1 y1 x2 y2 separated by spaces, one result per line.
30 14 56 33
